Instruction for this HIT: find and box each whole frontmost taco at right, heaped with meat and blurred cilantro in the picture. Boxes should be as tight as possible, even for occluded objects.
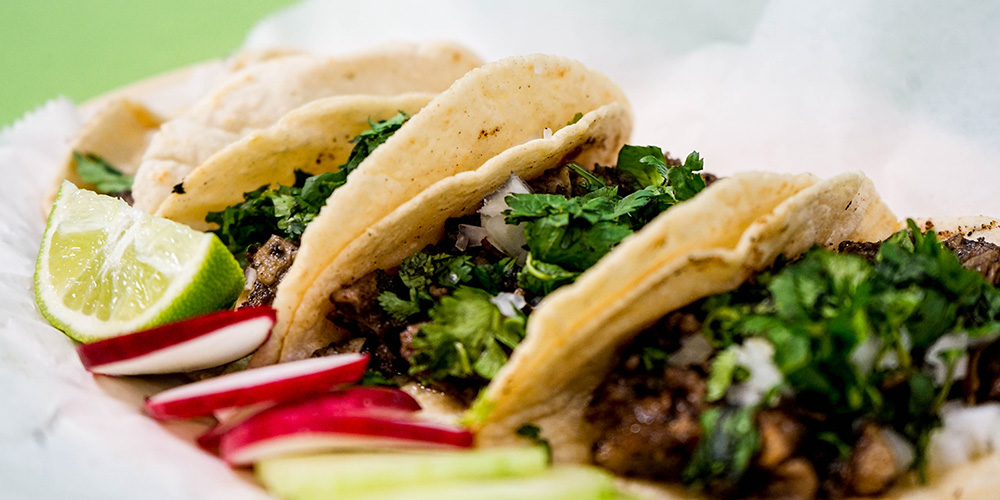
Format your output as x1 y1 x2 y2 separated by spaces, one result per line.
470 164 1000 499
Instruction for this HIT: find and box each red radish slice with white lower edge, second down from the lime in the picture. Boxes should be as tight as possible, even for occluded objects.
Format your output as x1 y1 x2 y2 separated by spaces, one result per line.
146 353 368 420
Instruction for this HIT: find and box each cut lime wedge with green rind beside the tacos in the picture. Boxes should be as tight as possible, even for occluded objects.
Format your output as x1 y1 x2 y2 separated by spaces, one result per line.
35 182 243 343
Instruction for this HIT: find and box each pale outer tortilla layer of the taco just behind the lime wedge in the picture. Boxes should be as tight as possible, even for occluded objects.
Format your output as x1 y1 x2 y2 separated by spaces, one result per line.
132 43 481 213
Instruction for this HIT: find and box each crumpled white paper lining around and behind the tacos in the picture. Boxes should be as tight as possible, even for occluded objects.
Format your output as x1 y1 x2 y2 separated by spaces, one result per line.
0 0 1000 500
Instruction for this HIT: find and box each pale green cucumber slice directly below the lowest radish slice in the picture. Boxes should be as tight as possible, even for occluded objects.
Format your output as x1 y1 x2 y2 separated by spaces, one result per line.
254 447 548 500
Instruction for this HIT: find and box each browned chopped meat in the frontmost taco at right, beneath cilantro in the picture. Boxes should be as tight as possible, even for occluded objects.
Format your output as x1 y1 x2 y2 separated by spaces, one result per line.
586 235 1000 500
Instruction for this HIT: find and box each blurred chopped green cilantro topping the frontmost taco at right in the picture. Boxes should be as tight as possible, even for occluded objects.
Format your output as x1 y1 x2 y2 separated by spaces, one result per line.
692 220 1000 484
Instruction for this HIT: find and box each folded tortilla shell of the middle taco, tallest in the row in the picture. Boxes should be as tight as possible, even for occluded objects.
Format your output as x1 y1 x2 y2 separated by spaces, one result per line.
253 56 631 366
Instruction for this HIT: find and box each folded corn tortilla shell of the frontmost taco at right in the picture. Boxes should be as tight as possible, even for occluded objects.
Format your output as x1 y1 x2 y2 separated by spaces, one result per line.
470 173 900 462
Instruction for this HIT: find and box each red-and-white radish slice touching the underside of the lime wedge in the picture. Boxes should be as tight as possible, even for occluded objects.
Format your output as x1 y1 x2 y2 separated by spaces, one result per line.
76 307 275 375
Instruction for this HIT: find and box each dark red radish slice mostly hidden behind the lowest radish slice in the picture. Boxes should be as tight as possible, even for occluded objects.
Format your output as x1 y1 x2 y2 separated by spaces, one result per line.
198 387 420 453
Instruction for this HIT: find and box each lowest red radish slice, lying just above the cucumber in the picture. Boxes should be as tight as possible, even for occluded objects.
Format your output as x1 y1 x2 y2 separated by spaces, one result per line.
219 402 473 466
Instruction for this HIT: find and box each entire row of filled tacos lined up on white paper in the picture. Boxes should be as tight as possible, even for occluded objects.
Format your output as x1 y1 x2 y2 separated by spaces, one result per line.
58 45 1000 498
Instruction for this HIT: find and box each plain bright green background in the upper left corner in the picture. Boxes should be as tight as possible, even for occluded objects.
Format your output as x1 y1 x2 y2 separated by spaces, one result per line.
0 0 293 128
